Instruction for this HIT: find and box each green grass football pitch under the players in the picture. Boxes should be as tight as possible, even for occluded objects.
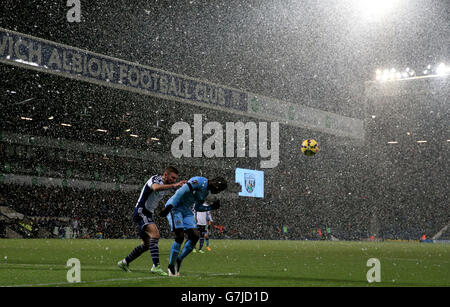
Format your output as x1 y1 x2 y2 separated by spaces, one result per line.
0 239 450 287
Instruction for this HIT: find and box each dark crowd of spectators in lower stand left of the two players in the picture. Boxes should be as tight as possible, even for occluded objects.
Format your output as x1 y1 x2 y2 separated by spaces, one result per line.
0 184 136 238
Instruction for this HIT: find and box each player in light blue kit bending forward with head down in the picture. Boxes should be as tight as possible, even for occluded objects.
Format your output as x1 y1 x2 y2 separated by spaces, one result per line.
160 177 227 276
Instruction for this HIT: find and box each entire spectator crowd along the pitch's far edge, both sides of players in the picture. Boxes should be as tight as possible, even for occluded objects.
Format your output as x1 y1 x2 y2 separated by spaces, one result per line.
0 184 446 240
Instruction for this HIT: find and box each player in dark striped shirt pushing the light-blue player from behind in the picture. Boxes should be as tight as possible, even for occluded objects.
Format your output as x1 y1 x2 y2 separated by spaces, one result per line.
117 166 186 276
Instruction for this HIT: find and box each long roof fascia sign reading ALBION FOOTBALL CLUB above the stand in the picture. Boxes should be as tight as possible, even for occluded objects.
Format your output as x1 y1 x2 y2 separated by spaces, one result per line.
0 28 364 140
